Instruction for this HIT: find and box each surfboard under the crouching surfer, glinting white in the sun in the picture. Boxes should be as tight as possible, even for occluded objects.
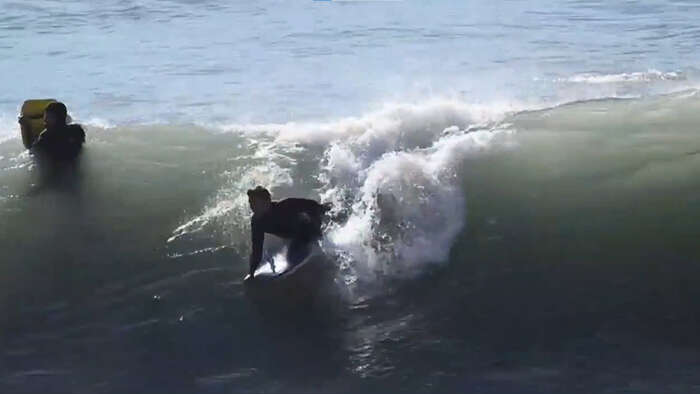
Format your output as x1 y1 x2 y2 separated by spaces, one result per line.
243 242 322 281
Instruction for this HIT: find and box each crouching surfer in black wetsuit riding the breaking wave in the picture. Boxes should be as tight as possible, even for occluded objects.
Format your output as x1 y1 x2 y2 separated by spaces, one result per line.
248 186 329 278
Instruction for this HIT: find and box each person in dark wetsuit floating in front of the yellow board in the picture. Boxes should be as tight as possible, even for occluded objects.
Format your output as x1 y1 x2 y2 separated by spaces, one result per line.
19 102 85 160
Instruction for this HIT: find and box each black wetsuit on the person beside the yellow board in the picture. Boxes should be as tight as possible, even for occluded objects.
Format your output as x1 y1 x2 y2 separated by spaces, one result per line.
31 124 85 160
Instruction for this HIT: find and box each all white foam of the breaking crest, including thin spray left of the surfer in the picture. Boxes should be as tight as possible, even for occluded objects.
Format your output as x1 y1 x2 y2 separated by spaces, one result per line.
169 99 522 282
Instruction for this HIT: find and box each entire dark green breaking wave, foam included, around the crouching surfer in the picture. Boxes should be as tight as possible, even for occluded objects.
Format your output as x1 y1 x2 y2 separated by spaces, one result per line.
0 90 700 392
